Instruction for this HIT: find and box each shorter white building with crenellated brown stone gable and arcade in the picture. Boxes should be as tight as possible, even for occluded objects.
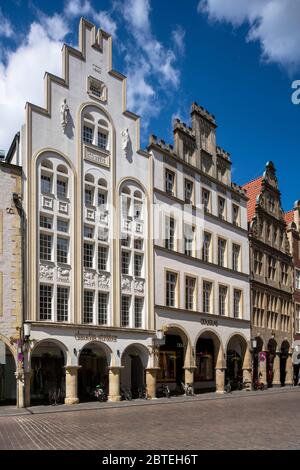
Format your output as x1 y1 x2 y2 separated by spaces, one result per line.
148 103 251 391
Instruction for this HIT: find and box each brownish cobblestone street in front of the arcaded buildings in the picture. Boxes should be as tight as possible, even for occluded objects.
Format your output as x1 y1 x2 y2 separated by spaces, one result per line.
0 389 300 450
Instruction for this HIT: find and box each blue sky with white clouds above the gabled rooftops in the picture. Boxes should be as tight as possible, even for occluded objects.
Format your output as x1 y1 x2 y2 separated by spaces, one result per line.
0 0 300 210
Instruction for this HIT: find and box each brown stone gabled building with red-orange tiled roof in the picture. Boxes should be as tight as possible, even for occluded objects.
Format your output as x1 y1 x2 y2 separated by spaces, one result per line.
243 162 294 386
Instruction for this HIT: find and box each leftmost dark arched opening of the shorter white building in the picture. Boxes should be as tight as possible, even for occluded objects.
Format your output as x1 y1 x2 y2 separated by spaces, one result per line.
157 327 190 393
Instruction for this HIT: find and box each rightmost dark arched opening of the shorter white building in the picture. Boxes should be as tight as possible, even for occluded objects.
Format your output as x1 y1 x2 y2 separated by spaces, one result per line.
225 334 247 389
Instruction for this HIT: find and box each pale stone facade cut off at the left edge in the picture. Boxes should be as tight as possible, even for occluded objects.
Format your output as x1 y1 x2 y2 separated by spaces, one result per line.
0 162 23 406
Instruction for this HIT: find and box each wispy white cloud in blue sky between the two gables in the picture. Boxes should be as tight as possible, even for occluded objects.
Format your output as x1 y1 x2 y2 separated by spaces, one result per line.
115 0 184 130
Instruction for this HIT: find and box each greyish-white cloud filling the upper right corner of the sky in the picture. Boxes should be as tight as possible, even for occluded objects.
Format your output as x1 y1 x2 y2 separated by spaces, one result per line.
198 0 300 71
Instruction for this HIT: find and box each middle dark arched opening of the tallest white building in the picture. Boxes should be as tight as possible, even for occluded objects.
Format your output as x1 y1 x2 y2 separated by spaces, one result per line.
78 343 110 401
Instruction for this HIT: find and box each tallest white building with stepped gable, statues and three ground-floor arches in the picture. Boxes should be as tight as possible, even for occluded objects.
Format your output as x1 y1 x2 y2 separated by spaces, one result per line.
6 19 155 405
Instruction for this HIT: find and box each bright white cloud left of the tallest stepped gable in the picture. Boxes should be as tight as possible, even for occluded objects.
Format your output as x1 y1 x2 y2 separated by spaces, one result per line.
0 22 66 149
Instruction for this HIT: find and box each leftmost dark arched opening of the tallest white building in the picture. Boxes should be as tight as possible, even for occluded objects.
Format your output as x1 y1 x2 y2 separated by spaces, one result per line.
30 341 66 405
